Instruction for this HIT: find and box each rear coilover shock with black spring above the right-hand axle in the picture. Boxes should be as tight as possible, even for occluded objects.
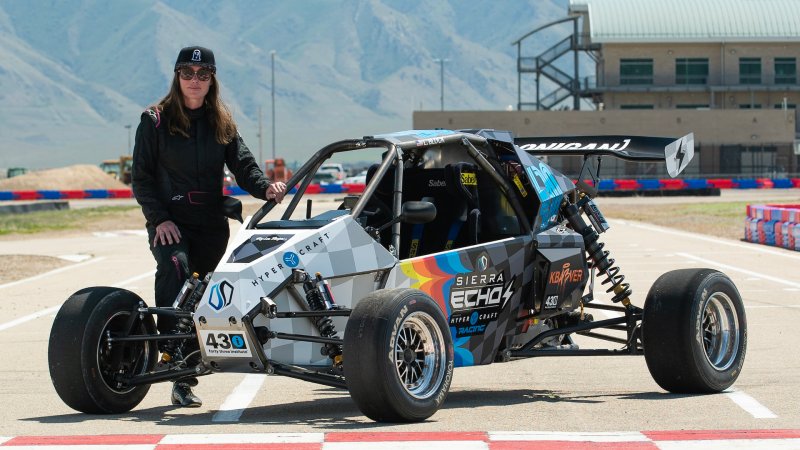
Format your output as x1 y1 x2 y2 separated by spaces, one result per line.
562 194 633 306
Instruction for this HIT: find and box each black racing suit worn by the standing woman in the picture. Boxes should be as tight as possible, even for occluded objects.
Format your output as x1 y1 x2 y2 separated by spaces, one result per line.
131 107 270 333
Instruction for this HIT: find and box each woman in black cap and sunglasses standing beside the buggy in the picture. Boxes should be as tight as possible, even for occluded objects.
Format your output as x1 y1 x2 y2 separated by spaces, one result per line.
132 47 286 407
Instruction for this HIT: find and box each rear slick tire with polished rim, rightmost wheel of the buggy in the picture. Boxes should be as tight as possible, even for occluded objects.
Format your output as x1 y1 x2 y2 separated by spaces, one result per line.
642 269 747 393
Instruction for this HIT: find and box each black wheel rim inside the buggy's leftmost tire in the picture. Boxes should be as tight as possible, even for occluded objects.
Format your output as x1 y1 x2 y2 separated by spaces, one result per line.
96 311 151 394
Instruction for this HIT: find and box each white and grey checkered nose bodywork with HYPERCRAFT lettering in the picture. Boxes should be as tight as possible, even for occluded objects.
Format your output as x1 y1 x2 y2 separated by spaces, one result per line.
195 216 397 366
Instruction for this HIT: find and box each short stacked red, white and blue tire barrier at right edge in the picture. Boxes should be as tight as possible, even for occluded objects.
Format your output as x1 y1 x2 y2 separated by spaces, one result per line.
744 205 800 251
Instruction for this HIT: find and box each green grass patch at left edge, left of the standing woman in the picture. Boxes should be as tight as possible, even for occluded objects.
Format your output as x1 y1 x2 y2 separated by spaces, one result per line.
0 206 139 235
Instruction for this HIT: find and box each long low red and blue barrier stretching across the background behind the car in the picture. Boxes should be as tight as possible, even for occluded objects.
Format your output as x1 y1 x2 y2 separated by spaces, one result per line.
0 178 800 201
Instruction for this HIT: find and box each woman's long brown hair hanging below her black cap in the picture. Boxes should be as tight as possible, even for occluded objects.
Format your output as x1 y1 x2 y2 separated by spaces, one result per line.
158 72 236 145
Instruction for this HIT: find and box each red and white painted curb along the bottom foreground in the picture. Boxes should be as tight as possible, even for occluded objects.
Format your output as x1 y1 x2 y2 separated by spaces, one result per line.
0 429 800 450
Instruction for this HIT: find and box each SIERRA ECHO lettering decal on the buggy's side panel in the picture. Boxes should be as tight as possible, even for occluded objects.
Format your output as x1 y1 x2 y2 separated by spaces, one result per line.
449 255 516 337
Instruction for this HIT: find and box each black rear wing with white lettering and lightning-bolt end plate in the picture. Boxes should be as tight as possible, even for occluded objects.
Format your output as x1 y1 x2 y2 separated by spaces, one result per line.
514 133 694 178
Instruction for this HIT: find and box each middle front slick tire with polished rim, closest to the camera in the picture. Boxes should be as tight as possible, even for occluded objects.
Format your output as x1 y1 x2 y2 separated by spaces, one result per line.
343 289 453 422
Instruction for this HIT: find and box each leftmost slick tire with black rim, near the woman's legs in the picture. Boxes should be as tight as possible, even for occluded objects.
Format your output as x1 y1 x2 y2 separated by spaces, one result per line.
48 287 158 414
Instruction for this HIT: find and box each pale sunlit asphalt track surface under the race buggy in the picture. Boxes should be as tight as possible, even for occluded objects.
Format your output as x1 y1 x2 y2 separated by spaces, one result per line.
0 192 800 442
